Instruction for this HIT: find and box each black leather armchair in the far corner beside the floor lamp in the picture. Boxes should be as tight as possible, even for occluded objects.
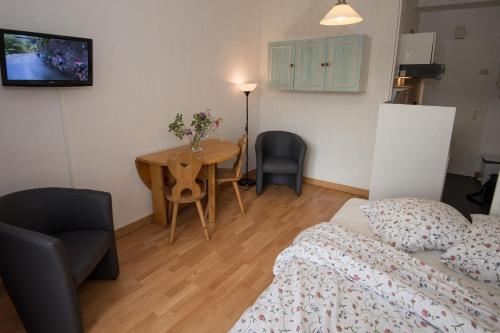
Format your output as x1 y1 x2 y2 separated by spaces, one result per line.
255 131 307 195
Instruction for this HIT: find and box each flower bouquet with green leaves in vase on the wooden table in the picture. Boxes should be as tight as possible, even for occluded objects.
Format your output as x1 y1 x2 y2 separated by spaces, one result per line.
168 110 222 152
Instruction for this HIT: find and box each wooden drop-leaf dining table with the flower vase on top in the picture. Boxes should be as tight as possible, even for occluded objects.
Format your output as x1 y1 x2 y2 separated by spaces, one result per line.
135 140 240 227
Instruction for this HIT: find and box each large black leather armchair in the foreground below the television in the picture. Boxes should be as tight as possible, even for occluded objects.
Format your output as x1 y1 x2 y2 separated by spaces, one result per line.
0 188 119 333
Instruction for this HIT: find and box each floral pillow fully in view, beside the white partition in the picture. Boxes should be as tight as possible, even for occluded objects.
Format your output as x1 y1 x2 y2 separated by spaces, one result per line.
361 198 469 252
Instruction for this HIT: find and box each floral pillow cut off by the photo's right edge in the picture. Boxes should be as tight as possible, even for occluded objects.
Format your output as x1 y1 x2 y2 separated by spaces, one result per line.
441 215 500 288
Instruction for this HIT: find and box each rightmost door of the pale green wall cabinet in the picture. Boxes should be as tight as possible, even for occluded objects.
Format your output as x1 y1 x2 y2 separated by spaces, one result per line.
325 35 364 92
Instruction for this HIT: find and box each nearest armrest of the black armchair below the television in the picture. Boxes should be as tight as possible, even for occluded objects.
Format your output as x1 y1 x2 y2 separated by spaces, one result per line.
0 222 82 332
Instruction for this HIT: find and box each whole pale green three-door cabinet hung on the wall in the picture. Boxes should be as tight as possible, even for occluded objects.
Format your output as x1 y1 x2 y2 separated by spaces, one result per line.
268 35 369 92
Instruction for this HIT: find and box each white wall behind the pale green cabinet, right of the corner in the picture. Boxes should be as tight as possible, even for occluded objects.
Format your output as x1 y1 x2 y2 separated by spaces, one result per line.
260 0 400 189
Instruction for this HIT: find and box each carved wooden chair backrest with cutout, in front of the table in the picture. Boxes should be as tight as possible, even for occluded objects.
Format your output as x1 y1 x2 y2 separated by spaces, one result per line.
167 151 203 201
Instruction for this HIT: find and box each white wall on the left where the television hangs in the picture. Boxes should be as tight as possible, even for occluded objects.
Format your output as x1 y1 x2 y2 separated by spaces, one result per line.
0 0 261 227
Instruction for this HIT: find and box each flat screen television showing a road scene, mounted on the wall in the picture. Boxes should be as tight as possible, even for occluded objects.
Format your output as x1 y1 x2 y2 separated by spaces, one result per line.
0 29 92 87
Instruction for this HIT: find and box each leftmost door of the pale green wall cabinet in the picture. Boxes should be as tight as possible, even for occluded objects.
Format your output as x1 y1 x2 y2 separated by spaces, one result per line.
268 41 295 90
